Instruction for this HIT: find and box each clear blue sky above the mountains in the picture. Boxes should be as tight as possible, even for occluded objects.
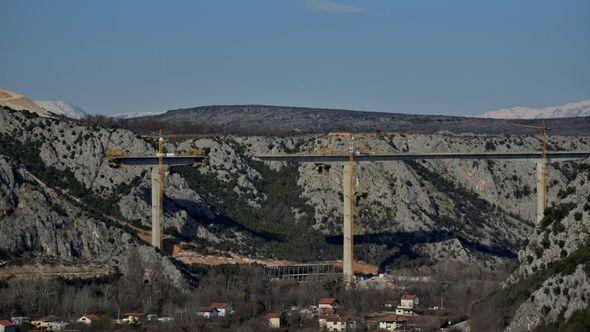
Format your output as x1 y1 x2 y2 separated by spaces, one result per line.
0 0 590 115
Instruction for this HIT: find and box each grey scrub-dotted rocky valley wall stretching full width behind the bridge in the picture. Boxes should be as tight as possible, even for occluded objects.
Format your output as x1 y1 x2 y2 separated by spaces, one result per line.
0 105 590 304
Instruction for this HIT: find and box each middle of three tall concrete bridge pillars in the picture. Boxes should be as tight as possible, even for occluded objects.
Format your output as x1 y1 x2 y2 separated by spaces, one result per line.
342 164 354 286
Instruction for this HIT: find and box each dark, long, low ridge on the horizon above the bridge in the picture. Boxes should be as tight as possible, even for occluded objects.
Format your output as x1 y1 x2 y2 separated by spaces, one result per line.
118 105 590 136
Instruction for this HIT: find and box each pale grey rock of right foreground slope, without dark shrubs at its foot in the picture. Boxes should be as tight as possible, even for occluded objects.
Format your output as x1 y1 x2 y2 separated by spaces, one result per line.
507 160 590 331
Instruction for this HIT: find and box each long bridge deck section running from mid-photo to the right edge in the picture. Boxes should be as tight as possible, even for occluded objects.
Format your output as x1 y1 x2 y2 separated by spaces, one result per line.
254 151 590 163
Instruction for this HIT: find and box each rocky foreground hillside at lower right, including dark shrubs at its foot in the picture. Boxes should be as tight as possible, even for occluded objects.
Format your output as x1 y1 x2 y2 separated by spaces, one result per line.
472 160 590 331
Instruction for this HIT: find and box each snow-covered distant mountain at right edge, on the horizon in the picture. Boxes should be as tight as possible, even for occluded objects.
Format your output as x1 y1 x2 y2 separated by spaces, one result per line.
481 100 590 119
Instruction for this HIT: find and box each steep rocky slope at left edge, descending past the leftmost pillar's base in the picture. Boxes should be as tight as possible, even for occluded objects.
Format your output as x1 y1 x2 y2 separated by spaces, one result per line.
0 155 190 288
